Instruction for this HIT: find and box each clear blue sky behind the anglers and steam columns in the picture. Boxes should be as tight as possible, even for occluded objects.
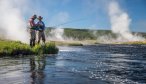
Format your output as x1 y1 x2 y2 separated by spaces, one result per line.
22 0 146 32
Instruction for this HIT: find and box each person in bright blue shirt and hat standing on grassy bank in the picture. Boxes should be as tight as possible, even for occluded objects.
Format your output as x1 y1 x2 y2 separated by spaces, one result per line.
37 16 46 44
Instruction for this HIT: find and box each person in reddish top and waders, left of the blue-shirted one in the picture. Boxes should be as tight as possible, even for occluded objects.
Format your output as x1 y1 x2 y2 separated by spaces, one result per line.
29 15 37 47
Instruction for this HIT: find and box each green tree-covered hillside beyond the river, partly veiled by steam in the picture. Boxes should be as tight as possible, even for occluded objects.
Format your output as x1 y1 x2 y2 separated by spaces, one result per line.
46 28 146 40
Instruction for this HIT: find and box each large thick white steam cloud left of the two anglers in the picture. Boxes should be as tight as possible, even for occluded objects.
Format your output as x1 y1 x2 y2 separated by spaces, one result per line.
0 0 28 43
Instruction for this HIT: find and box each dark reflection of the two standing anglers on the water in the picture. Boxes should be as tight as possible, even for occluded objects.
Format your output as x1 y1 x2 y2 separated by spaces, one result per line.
30 56 46 84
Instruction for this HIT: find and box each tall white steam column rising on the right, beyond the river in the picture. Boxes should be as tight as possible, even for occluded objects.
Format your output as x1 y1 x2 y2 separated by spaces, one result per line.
109 1 144 41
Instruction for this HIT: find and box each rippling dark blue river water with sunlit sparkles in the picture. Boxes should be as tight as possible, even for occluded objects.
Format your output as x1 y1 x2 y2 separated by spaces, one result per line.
0 45 146 84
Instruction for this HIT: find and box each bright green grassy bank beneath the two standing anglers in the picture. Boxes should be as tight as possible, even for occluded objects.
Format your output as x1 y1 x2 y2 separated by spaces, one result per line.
0 41 59 56
